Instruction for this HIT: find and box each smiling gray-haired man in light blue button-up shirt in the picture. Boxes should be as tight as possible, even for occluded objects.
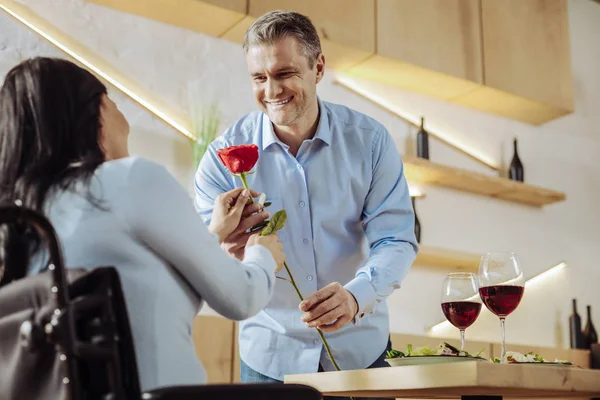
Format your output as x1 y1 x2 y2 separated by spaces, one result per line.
195 11 417 396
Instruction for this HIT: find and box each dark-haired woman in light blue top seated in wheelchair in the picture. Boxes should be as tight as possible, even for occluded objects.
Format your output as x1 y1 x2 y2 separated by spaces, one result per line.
0 58 285 390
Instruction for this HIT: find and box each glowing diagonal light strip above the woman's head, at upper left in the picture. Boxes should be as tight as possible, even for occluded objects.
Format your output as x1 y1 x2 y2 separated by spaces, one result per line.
0 0 195 140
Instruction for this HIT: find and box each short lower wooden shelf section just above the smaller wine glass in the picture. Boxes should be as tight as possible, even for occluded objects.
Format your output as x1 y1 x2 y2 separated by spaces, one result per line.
414 245 481 272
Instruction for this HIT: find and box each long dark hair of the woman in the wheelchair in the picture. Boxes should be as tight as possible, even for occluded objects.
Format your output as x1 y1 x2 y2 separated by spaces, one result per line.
0 57 106 286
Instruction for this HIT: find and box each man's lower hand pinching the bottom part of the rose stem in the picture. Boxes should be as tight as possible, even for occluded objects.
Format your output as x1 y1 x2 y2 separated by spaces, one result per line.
299 282 358 332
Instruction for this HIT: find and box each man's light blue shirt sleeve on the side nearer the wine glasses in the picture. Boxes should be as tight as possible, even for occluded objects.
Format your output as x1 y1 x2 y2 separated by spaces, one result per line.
345 128 418 323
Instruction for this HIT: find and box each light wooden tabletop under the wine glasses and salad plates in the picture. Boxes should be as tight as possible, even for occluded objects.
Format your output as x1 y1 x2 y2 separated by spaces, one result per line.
285 361 600 399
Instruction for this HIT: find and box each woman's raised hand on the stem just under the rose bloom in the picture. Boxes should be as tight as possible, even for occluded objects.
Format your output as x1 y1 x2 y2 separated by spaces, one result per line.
208 188 268 245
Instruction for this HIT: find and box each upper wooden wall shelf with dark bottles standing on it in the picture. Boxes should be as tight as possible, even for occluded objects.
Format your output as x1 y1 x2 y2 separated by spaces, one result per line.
403 156 567 207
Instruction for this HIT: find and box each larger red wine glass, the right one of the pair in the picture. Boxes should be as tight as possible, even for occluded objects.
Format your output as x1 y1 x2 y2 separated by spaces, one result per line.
478 253 525 364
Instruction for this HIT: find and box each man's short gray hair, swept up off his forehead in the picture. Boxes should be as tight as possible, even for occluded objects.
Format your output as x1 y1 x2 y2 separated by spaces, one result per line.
244 10 321 68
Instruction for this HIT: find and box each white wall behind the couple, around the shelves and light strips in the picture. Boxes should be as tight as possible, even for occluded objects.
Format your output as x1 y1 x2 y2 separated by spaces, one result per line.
0 0 600 346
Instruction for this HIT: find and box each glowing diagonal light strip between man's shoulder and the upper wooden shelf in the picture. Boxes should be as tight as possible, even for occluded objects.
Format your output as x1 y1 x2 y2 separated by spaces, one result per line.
334 75 500 171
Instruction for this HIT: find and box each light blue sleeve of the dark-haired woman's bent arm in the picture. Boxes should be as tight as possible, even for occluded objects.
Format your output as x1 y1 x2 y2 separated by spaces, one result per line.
126 159 276 320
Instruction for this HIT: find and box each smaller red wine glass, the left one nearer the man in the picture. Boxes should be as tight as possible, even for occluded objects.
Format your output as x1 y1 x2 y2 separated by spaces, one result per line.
442 272 481 351
